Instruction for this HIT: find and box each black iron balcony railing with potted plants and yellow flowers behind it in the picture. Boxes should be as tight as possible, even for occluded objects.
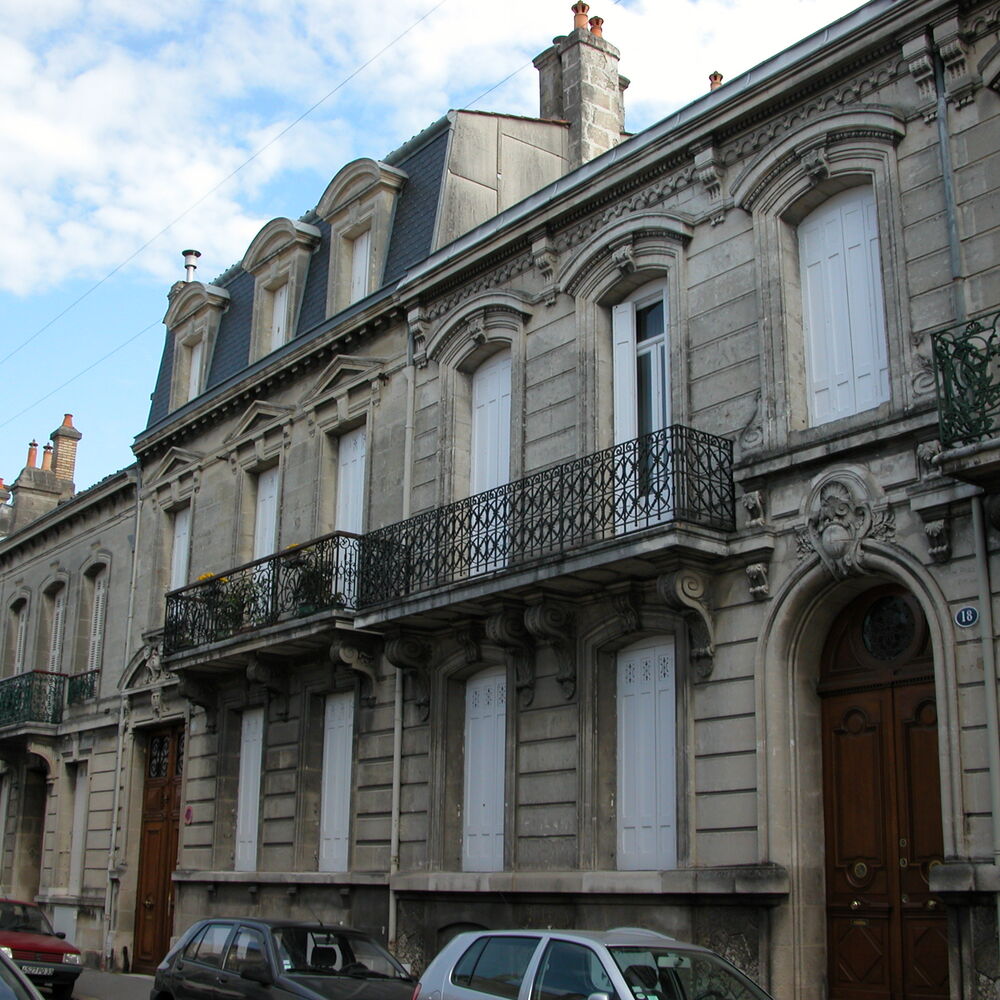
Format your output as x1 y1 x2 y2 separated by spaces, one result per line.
163 532 360 654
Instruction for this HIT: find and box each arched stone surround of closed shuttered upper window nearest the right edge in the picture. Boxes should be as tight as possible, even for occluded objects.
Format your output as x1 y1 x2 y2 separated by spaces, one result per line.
731 106 916 448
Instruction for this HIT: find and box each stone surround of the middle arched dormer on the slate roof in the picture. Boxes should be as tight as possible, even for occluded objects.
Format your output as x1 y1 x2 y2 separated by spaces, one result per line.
240 218 322 362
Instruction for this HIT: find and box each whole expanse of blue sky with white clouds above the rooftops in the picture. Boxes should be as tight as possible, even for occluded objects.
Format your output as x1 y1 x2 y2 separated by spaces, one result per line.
0 0 860 496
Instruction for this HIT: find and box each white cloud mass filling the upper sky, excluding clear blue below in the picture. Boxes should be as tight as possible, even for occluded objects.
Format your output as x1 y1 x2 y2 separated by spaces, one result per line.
0 0 868 294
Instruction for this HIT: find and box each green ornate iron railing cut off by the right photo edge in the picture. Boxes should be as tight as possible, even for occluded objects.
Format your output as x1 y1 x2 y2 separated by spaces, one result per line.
931 313 1000 447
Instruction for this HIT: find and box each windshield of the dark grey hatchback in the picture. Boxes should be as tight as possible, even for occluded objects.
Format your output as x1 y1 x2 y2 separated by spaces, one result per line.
274 927 410 979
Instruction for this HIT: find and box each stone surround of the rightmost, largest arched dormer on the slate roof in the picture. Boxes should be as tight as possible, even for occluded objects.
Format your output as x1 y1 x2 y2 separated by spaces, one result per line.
316 158 407 316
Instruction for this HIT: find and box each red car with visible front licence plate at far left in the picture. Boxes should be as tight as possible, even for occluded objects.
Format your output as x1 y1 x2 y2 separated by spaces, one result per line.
0 899 83 1000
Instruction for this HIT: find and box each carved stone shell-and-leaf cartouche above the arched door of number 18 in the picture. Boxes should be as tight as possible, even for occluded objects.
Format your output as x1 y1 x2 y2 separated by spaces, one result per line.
795 474 896 580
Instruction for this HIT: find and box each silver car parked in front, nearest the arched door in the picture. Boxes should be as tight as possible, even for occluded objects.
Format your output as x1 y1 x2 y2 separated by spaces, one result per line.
413 927 769 1000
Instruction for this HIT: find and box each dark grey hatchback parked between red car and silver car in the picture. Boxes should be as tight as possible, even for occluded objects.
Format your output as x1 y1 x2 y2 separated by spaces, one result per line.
150 918 414 1000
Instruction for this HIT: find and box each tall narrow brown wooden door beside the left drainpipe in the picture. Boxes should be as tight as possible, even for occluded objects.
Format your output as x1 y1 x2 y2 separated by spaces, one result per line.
132 729 184 973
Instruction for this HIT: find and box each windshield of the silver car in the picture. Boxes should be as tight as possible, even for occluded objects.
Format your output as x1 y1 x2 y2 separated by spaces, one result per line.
608 947 768 1000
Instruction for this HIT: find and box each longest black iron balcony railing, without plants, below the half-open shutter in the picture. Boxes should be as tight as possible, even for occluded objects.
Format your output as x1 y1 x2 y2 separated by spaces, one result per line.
358 426 735 607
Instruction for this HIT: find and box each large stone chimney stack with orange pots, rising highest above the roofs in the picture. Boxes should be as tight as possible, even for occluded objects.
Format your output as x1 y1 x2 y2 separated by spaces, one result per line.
535 0 628 170
